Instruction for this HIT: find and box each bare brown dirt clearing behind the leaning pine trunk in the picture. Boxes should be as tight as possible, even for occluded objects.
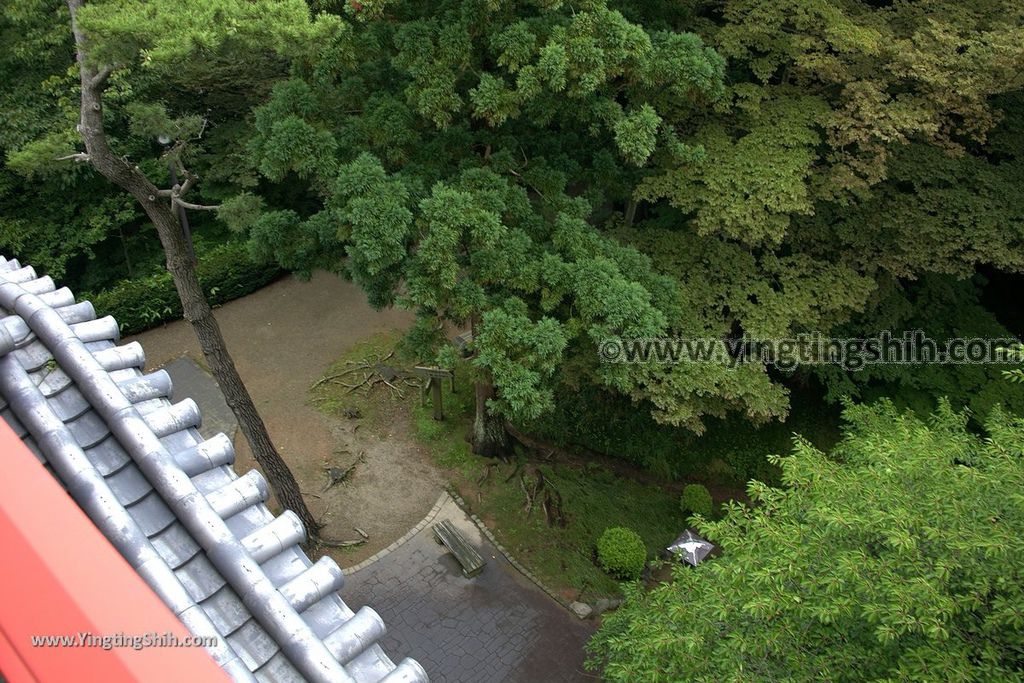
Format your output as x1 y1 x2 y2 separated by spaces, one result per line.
126 272 445 567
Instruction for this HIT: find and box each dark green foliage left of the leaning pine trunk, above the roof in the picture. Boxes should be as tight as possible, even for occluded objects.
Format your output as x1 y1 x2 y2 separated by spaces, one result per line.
0 0 139 278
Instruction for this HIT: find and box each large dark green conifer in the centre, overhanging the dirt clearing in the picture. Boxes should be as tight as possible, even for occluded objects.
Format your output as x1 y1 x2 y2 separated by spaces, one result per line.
239 0 798 455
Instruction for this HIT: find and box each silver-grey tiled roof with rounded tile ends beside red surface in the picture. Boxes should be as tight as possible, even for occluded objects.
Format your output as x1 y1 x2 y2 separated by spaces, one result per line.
0 257 427 683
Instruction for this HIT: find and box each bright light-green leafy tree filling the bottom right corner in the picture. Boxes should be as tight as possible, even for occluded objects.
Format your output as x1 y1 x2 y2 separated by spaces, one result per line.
590 403 1024 681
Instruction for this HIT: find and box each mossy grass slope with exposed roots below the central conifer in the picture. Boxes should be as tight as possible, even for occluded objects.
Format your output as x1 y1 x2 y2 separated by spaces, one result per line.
312 334 704 602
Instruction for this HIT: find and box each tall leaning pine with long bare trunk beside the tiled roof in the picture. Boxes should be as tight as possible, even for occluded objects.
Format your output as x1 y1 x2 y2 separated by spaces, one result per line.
60 0 332 542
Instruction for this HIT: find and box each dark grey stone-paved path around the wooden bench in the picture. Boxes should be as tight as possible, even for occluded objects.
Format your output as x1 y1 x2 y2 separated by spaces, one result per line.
341 500 597 683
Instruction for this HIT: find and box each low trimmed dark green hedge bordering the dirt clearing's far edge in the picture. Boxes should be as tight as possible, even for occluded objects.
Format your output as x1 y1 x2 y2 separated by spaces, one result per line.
86 242 284 335
